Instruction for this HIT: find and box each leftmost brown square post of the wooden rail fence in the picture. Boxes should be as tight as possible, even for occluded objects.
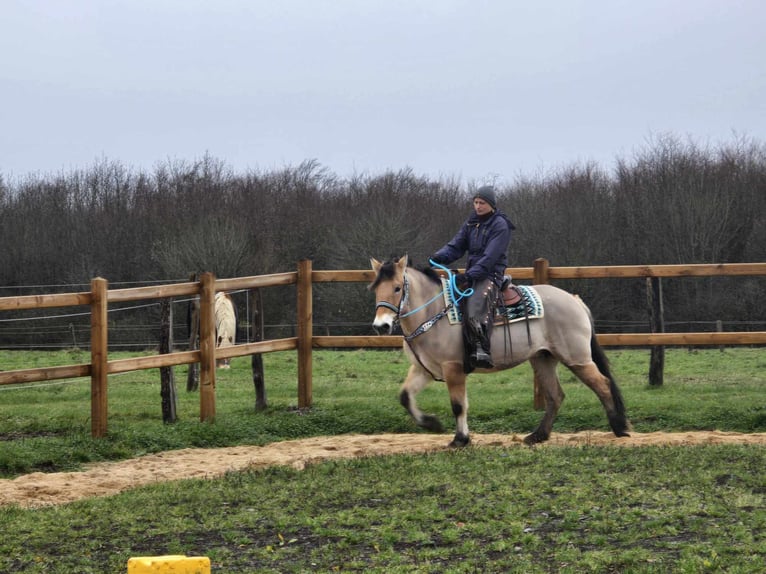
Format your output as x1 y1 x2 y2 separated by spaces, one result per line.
90 277 109 438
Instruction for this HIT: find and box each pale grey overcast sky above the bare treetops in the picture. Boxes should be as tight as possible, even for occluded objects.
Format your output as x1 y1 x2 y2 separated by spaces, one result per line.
0 0 766 184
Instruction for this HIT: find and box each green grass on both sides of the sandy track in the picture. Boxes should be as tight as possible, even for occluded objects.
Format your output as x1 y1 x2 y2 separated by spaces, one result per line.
0 348 766 573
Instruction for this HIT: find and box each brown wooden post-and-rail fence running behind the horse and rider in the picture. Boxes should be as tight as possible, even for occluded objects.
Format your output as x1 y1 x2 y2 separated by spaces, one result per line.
0 259 766 437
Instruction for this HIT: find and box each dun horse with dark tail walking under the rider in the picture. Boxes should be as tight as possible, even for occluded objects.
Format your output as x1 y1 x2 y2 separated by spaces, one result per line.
368 255 630 447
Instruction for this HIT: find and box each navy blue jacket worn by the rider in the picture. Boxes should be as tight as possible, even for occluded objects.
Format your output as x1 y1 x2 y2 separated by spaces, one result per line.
434 211 515 287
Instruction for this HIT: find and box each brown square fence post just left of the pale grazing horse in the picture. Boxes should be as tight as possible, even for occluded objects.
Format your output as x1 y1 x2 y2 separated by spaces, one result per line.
199 272 215 422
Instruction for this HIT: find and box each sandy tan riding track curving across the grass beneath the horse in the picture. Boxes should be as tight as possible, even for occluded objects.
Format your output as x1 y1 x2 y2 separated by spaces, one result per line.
0 431 766 507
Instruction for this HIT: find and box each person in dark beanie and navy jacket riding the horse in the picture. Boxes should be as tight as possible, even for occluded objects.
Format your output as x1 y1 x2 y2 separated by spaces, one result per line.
431 185 515 370
